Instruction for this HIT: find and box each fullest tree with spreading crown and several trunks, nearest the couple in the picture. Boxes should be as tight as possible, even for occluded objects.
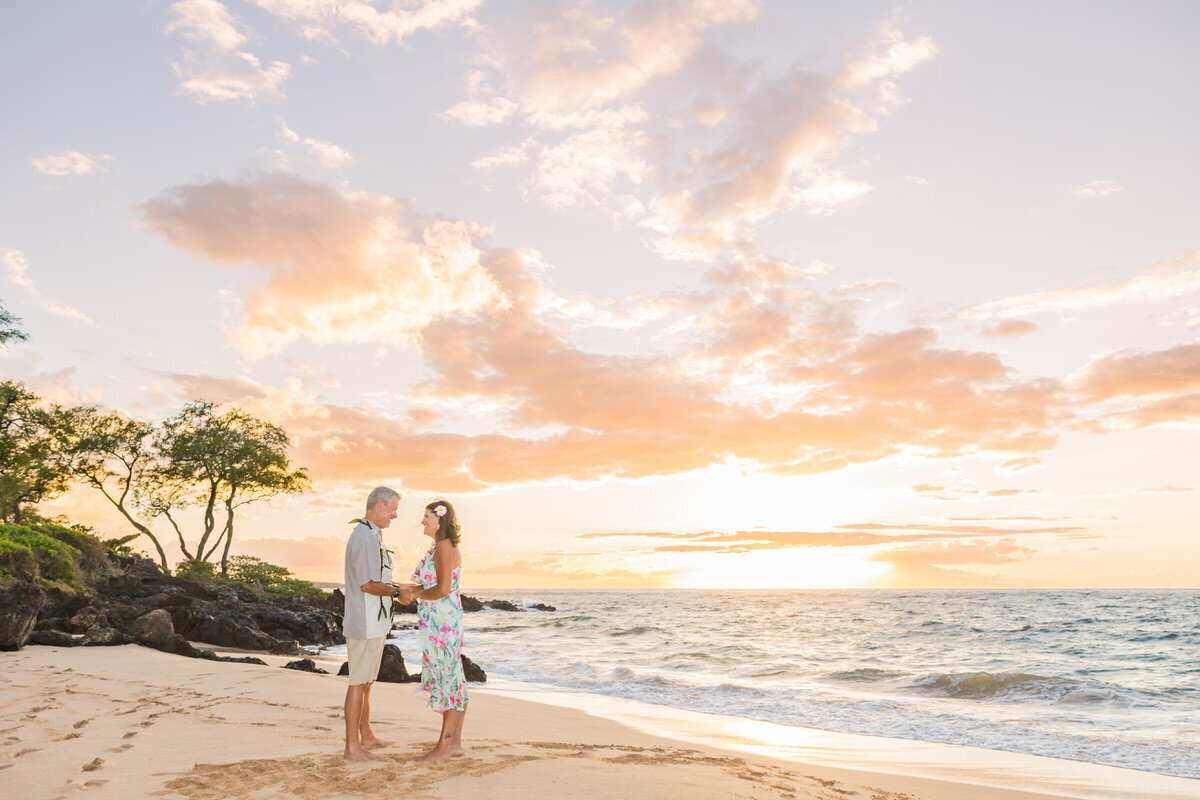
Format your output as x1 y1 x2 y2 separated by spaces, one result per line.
144 401 310 573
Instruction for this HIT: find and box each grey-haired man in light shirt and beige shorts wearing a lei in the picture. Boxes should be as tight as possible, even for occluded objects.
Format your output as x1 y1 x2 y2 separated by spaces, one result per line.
342 486 401 762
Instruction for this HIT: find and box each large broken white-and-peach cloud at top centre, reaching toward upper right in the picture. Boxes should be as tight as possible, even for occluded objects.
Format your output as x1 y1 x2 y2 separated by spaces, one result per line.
444 7 936 260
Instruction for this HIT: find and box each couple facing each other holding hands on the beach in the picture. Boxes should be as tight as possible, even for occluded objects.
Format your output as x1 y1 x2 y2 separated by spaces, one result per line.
342 486 468 760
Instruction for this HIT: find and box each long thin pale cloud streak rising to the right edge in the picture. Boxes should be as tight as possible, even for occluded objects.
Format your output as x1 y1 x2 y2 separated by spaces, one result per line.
965 251 1200 318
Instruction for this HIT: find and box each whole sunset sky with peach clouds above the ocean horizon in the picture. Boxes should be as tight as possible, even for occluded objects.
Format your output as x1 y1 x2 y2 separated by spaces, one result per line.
0 0 1200 590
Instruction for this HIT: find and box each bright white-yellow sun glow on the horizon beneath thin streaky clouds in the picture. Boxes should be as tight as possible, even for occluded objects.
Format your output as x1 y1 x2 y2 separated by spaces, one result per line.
676 547 892 589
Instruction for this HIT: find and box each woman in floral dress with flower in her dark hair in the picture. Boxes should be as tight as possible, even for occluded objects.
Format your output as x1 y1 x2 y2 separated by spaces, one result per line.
409 500 467 760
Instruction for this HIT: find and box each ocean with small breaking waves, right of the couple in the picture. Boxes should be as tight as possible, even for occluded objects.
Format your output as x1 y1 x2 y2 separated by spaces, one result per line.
328 590 1200 778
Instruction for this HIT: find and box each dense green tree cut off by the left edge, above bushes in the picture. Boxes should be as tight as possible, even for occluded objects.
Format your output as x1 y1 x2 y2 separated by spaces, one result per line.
0 380 74 523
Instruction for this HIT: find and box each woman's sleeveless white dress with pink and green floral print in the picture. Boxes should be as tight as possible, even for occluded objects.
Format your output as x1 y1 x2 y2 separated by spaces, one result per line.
412 542 468 714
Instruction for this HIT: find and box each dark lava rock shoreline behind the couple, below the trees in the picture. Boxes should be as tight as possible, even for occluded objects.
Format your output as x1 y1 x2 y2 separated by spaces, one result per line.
0 554 554 682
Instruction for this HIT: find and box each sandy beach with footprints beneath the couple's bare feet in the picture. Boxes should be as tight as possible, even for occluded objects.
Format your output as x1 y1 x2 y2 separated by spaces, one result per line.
0 645 1195 800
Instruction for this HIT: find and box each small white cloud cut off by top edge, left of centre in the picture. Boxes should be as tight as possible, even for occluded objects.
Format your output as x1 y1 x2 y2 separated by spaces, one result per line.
253 0 482 44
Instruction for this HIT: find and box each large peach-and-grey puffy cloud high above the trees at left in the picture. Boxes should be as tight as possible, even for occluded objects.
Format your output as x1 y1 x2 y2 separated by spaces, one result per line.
142 174 506 357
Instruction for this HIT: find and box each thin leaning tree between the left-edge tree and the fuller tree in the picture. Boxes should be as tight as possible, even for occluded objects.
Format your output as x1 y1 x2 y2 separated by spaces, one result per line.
71 407 169 570
